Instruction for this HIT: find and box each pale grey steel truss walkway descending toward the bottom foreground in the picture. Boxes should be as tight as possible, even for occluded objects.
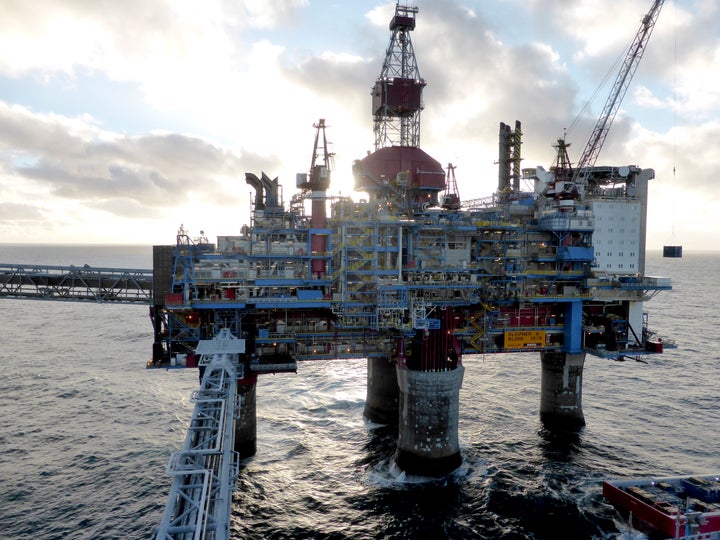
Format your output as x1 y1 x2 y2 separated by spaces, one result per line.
156 329 245 540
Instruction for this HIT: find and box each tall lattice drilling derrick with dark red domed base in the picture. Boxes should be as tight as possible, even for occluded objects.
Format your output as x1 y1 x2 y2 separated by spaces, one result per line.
353 4 445 213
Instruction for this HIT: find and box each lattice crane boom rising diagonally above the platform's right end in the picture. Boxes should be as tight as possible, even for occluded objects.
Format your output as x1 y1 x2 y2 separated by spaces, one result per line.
574 0 665 183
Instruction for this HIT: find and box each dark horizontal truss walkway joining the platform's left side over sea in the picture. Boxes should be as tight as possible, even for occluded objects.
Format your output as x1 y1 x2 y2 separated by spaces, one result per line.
0 264 153 304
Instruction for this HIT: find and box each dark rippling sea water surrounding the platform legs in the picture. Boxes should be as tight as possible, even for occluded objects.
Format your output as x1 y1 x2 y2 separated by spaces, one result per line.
0 245 720 539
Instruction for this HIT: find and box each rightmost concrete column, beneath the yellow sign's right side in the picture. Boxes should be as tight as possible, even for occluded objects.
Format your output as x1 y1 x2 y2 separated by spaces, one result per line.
540 352 585 428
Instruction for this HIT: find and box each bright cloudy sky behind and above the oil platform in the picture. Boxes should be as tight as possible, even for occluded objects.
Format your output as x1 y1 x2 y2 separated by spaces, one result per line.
0 0 720 250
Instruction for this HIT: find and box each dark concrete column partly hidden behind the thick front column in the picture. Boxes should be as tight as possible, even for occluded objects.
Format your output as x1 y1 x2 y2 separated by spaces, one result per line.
364 357 398 424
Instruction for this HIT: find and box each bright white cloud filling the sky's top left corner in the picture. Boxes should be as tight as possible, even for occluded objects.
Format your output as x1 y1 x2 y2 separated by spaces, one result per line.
0 0 308 81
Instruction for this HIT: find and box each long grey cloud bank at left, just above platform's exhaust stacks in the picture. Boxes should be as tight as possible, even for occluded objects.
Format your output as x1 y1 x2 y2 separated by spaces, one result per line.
0 102 277 217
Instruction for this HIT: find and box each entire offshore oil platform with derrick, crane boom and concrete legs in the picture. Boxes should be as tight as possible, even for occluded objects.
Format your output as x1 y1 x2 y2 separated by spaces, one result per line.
149 1 671 484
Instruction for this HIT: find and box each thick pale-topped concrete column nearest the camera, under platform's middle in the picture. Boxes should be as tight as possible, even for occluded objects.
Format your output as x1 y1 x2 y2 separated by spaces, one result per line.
395 365 465 476
